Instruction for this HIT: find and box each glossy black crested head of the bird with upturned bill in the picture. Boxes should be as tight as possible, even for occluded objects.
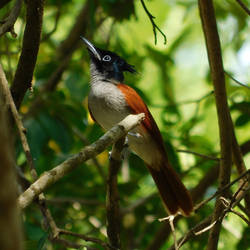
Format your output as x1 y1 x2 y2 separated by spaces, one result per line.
81 37 136 82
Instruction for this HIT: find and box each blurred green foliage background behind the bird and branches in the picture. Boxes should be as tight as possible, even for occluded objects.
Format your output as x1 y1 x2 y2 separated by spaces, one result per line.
0 0 250 250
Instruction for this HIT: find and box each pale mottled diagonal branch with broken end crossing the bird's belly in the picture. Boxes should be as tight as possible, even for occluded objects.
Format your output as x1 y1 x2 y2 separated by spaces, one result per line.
18 114 144 208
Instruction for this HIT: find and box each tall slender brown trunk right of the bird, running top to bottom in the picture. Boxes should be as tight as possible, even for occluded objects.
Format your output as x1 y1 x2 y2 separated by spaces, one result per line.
198 0 233 250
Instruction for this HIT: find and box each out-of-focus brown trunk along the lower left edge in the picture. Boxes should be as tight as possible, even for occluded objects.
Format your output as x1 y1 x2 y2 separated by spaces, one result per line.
0 86 23 250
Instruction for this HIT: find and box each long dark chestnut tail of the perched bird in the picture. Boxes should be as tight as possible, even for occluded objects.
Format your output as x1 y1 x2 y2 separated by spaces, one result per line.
147 163 193 216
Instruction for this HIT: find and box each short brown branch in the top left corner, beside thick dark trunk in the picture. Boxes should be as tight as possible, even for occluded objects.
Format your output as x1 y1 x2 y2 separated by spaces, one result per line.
0 0 23 37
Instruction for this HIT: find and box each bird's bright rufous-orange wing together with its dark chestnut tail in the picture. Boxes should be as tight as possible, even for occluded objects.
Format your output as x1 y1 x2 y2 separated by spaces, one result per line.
117 84 193 216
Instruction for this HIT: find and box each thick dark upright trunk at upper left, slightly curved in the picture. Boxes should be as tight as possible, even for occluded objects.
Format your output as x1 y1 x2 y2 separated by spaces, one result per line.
11 0 44 109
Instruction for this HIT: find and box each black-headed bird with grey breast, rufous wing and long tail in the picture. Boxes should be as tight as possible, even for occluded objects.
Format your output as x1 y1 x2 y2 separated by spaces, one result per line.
81 36 193 216
